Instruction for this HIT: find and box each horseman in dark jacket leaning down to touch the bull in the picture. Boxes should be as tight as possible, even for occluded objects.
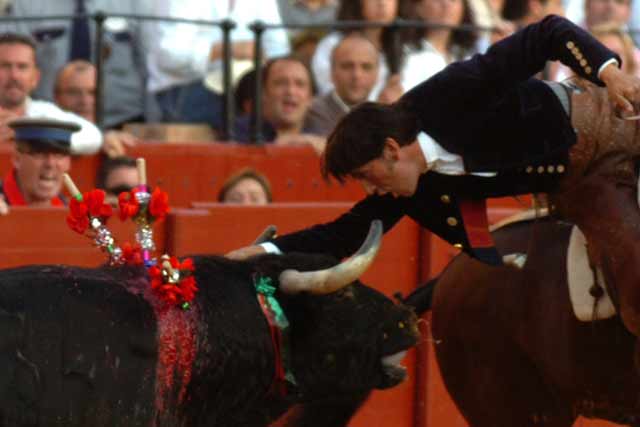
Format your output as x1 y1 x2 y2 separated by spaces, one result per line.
228 16 640 265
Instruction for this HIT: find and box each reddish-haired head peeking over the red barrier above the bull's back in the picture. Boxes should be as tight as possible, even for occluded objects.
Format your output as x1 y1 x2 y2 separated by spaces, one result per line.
218 168 272 205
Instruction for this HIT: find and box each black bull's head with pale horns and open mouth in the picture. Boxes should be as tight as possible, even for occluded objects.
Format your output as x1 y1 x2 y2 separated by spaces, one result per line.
244 221 419 396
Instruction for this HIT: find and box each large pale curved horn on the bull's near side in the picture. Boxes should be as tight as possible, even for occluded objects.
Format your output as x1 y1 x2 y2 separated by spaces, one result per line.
280 219 382 295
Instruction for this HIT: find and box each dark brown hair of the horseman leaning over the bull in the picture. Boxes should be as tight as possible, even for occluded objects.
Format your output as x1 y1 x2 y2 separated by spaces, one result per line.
322 102 419 182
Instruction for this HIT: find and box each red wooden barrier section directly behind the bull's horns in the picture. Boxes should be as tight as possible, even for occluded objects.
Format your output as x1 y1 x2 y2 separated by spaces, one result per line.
167 203 419 427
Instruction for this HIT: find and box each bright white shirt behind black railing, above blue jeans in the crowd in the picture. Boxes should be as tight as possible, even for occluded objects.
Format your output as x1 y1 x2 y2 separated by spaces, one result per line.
147 0 289 92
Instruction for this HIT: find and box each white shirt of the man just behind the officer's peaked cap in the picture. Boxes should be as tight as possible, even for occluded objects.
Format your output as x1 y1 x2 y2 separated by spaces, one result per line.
25 98 102 154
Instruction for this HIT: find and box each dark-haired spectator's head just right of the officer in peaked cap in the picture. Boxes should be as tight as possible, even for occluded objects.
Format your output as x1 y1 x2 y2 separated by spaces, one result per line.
96 156 140 206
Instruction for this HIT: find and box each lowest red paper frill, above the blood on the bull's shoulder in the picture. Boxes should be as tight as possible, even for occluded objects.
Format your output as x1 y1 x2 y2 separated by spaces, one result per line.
149 257 198 305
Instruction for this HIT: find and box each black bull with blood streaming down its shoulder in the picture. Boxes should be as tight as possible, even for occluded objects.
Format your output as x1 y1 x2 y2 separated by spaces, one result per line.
0 254 417 427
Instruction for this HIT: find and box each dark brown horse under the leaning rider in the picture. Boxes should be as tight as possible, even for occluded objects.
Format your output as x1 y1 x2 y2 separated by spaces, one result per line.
407 88 640 427
